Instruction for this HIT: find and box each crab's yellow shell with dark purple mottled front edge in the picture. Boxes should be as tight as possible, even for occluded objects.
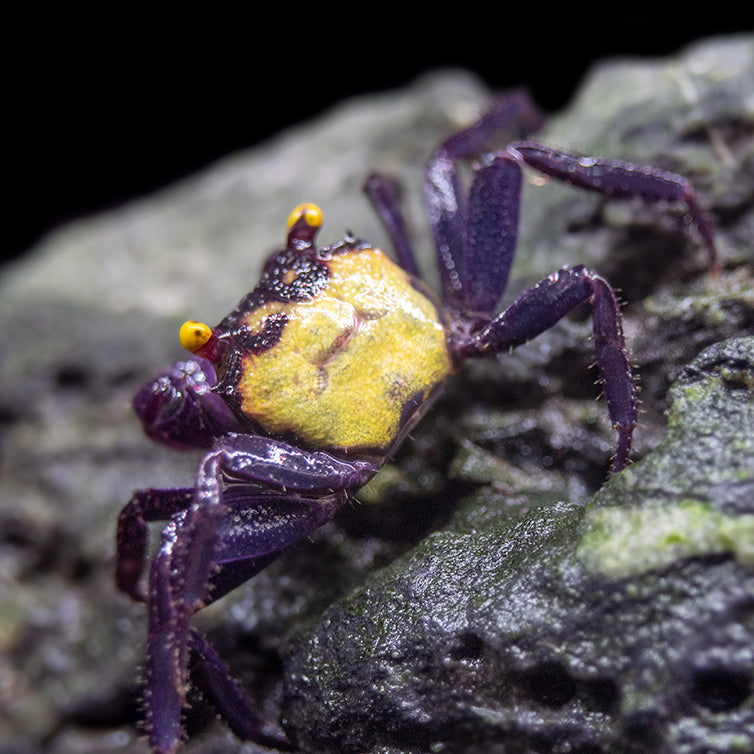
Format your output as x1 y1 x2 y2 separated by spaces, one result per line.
209 241 450 456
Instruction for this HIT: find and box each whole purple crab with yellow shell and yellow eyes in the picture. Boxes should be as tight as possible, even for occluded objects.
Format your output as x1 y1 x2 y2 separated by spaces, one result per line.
116 92 718 753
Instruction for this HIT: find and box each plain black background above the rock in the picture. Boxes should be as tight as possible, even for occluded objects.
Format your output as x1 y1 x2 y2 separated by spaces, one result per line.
0 2 744 260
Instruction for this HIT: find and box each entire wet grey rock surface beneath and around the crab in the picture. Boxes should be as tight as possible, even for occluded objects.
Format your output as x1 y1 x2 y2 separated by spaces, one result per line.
0 36 754 754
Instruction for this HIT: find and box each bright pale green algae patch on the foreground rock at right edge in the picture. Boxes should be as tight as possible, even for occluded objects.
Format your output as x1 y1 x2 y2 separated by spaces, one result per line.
577 500 754 578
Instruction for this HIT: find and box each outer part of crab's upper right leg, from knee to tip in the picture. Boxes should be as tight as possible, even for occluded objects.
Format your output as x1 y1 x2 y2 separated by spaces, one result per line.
508 141 720 270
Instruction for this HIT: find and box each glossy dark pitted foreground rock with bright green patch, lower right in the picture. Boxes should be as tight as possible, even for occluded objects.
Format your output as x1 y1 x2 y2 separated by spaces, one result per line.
285 338 754 754
